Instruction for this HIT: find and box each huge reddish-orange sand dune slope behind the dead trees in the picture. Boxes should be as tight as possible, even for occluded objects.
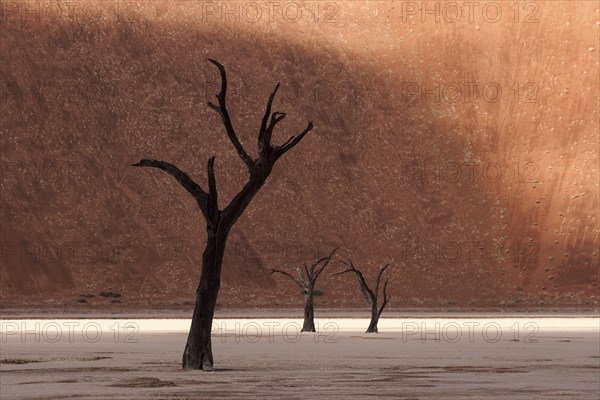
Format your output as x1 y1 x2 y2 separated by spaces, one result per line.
0 1 600 309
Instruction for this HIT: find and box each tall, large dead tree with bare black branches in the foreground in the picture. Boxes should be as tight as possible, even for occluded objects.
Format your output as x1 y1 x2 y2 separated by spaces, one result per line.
133 60 313 370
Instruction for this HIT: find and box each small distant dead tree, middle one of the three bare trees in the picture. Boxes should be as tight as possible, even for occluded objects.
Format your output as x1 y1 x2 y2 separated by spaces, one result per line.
271 247 337 332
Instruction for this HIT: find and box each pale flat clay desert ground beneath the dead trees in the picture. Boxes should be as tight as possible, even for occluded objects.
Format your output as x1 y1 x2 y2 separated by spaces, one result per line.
0 314 600 399
